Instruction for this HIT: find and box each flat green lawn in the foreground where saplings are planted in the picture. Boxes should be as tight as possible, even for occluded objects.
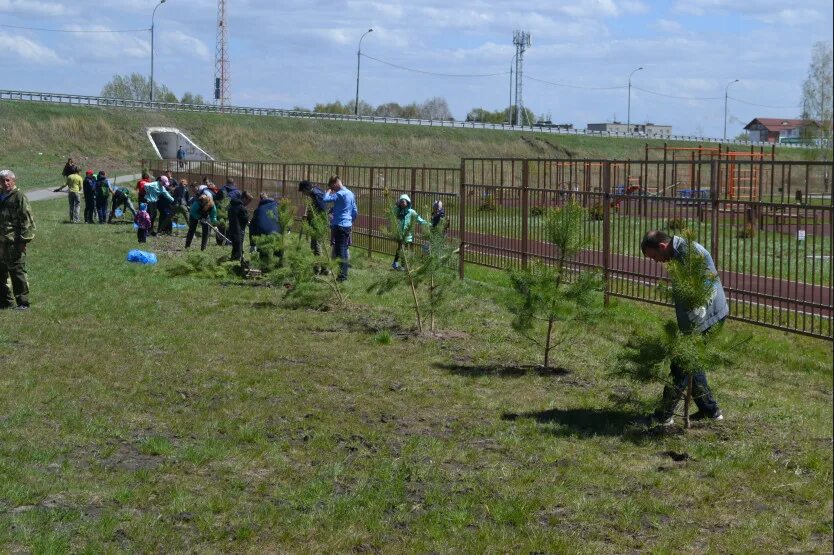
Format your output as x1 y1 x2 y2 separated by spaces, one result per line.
0 201 832 553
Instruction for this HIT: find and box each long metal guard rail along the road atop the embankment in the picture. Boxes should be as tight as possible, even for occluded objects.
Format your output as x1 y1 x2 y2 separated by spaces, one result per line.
0 89 819 149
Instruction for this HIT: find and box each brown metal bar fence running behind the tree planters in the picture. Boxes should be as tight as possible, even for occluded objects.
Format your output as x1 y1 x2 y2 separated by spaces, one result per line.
143 159 834 339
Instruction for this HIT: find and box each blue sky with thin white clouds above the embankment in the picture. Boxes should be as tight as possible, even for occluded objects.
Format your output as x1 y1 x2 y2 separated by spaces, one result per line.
0 0 834 137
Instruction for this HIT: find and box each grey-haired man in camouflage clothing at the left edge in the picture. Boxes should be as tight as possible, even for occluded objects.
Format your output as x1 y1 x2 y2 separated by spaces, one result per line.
0 170 35 310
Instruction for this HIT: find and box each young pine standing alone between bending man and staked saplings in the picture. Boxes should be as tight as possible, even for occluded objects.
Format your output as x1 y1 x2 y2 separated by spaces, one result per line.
508 202 602 368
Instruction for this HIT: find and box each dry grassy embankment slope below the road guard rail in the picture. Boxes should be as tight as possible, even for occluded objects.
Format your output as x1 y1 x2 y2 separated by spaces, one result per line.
0 102 799 189
